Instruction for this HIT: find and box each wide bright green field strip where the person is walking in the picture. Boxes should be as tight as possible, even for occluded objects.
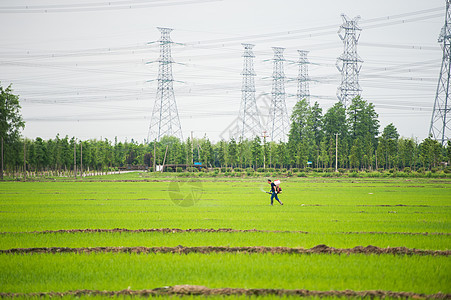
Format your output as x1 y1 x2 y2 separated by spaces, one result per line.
0 178 451 233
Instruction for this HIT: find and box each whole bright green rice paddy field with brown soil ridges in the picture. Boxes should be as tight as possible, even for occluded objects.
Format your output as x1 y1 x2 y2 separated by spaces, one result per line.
0 172 451 299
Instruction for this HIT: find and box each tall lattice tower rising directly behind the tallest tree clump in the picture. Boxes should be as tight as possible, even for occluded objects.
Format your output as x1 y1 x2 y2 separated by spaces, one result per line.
336 14 363 107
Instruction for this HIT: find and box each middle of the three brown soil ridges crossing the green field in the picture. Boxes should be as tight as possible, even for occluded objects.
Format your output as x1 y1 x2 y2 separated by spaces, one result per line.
0 245 451 256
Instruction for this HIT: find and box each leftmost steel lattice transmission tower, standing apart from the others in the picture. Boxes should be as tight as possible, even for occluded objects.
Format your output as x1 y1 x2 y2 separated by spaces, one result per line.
148 27 183 141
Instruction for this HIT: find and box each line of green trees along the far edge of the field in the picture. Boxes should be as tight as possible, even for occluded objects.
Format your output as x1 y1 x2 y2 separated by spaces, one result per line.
0 83 451 176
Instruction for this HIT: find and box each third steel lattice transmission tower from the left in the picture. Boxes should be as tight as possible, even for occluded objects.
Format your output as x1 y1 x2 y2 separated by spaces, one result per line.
268 47 290 142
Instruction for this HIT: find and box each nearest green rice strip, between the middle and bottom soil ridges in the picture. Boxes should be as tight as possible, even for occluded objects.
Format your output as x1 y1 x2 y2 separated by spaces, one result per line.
0 253 451 294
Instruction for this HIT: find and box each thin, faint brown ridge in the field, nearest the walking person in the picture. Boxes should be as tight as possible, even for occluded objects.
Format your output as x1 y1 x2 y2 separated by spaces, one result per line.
0 228 451 235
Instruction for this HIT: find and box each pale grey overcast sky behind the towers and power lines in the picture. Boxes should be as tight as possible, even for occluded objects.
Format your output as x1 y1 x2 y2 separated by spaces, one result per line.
0 0 445 142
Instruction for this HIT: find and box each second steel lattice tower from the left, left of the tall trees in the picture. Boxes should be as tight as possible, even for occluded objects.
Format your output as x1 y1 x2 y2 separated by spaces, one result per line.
239 44 262 139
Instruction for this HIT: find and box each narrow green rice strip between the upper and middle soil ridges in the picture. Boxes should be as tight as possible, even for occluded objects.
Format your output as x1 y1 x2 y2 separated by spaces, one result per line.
0 232 451 250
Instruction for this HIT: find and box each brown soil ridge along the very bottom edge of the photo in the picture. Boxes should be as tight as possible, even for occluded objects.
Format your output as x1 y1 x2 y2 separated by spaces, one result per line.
0 285 451 299
